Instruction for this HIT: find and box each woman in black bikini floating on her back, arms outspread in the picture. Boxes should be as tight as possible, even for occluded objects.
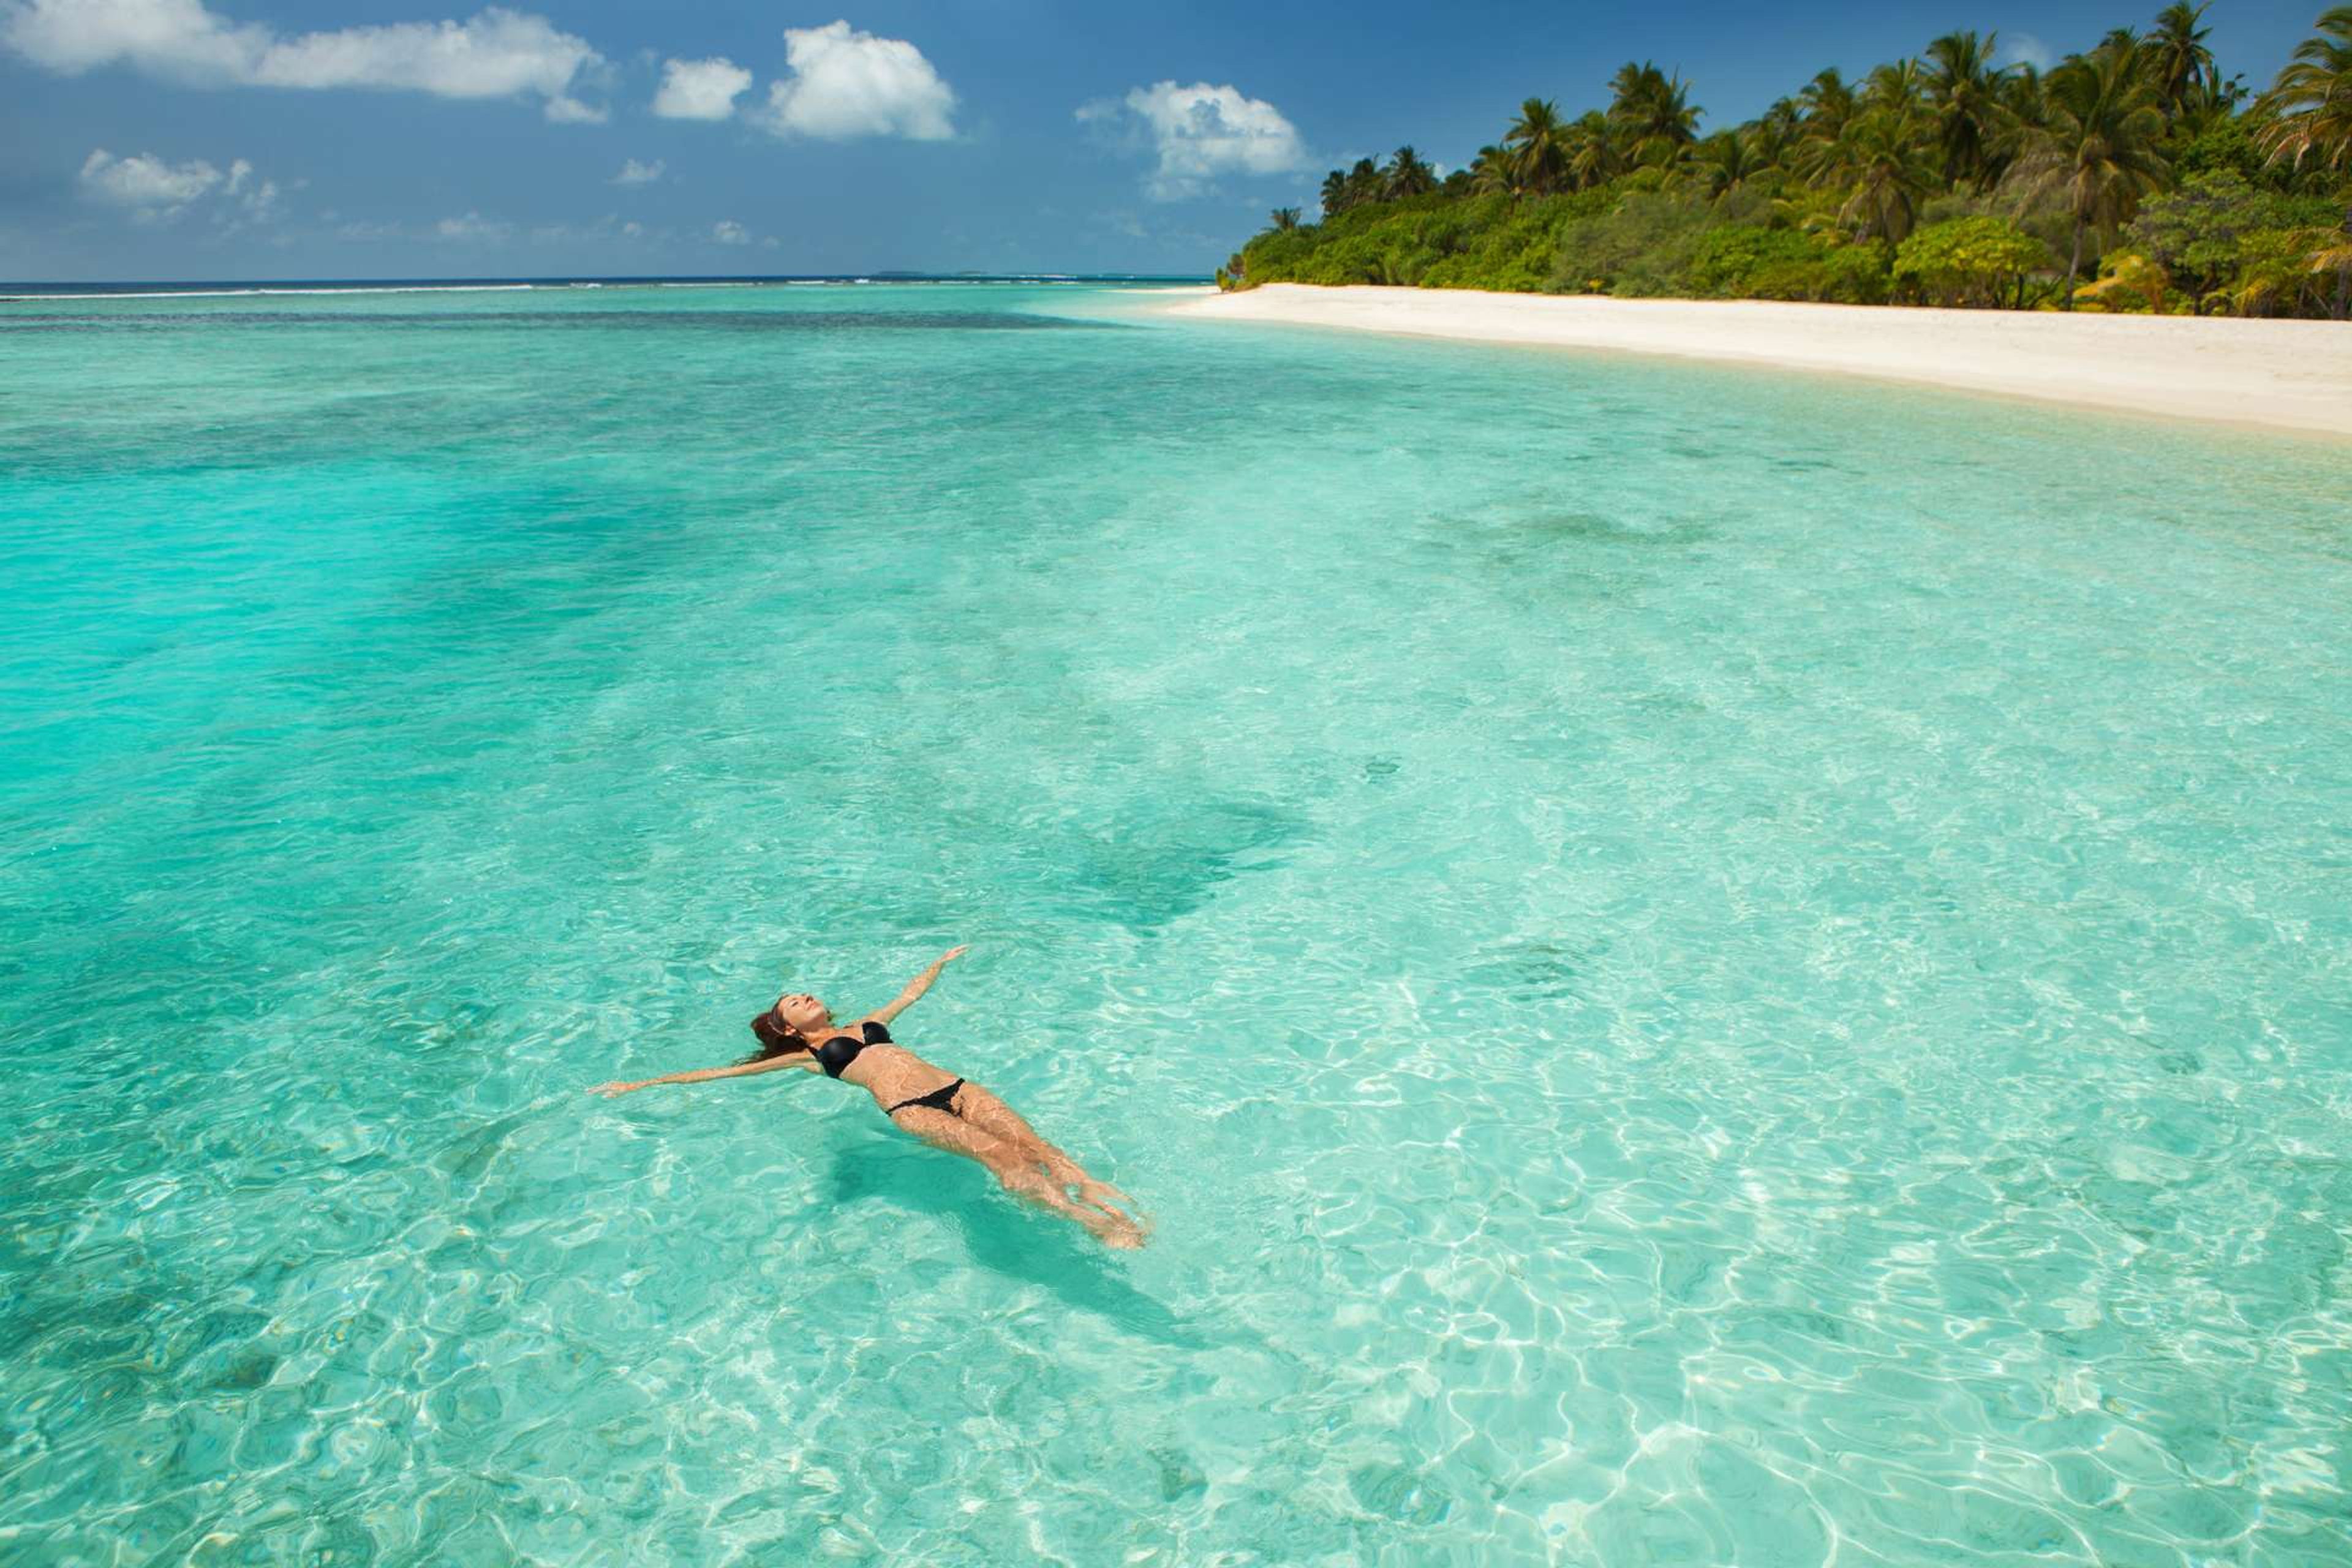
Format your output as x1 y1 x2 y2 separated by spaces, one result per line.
595 948 1143 1246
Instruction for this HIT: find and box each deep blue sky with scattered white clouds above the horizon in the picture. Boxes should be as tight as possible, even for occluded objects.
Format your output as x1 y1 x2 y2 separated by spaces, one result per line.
0 0 2319 280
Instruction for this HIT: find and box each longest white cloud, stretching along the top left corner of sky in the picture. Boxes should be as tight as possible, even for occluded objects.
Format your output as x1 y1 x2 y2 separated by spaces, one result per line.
0 0 605 123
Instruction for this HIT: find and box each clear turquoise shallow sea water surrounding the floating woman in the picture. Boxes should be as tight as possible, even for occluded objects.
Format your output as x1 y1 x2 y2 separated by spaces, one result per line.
0 287 2352 1568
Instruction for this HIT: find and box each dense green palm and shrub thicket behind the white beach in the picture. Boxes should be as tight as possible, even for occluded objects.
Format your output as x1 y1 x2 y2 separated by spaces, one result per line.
1216 5 2352 320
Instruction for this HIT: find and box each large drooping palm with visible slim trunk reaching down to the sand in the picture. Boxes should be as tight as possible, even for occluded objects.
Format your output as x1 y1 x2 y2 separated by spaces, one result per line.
2011 45 2168 311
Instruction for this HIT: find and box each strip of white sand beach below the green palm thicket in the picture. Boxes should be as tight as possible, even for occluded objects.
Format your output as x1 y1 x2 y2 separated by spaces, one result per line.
1176 282 2352 435
